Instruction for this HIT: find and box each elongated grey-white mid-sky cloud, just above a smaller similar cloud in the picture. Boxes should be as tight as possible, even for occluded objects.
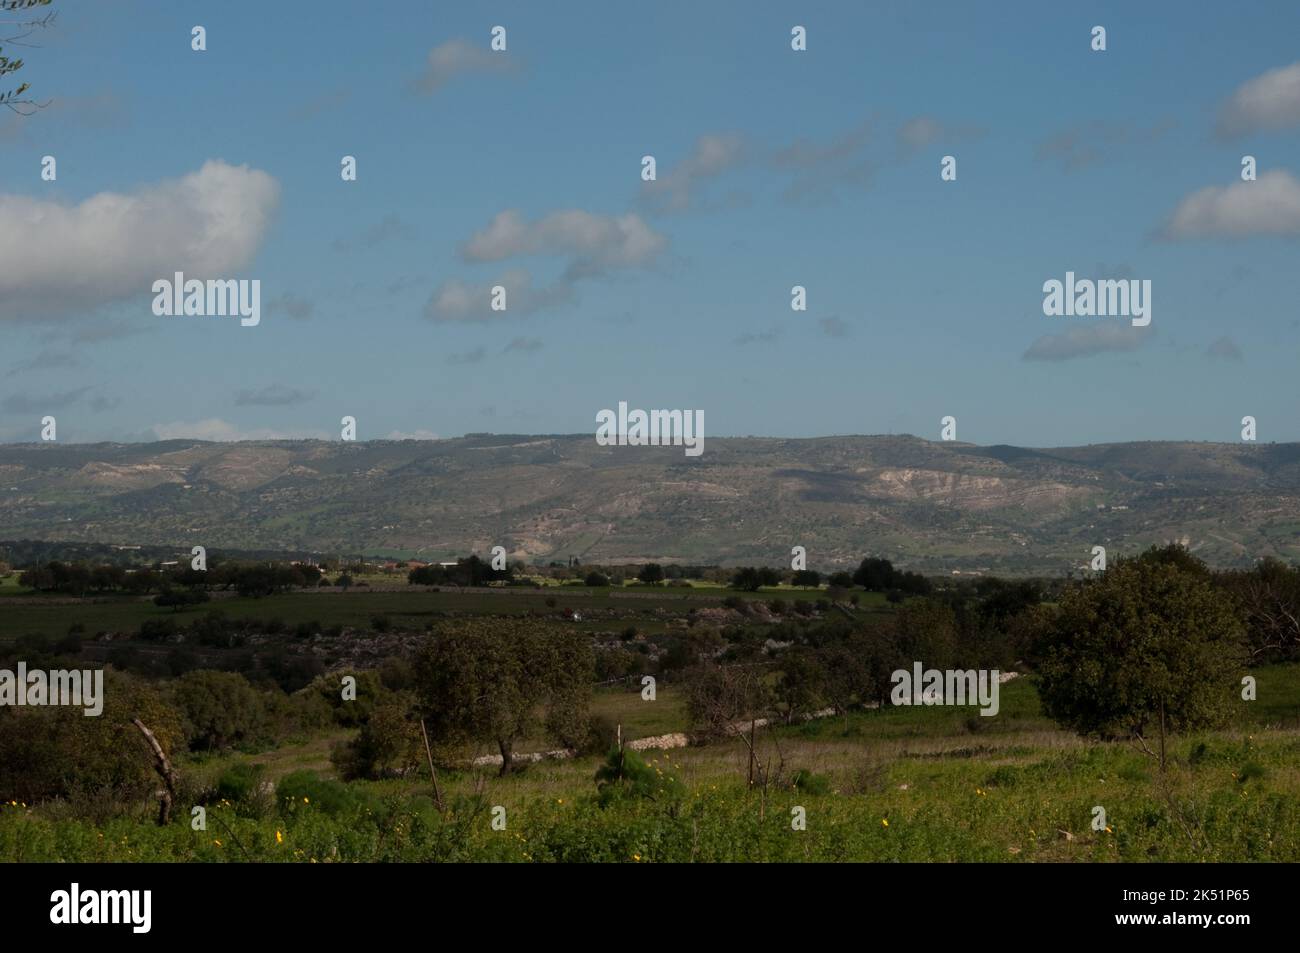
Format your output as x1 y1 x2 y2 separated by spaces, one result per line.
460 208 667 280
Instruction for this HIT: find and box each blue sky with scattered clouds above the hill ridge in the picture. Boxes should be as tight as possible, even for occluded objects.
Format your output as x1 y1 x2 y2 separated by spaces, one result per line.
0 0 1300 446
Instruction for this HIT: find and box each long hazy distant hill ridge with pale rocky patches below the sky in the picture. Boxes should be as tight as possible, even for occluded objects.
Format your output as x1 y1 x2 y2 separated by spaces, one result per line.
0 434 1300 575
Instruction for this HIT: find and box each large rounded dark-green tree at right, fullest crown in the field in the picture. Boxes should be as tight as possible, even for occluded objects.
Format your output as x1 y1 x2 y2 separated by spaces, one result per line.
1037 549 1243 767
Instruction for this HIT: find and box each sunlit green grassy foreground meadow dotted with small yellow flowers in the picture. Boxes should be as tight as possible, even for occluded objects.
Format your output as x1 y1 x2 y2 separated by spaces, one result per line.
0 666 1300 862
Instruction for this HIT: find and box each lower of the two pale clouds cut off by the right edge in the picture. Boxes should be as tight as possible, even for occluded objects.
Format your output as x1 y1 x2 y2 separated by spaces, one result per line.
1160 169 1300 239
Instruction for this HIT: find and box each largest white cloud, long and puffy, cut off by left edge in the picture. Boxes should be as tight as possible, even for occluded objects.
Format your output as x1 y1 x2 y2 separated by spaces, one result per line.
0 160 280 320
